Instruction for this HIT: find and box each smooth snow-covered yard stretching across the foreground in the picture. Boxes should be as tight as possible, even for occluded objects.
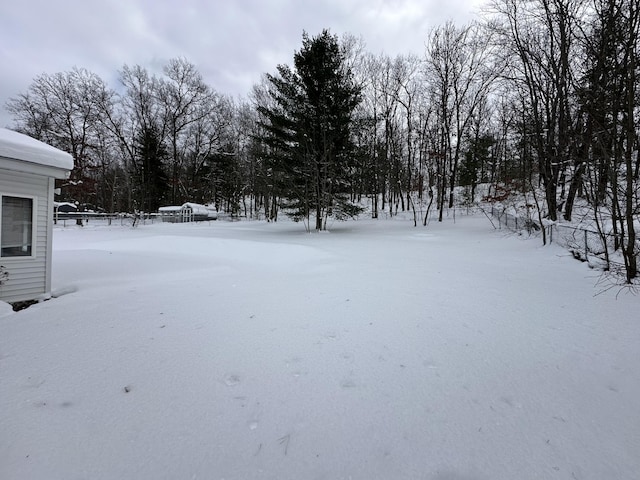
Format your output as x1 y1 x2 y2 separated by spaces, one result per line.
0 217 640 480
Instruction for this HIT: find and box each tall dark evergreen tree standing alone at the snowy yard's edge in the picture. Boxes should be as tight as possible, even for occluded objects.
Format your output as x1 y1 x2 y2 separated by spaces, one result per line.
258 30 360 230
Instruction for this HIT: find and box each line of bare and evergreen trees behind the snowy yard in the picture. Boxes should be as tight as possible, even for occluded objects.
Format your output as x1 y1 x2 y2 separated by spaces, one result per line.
7 0 640 282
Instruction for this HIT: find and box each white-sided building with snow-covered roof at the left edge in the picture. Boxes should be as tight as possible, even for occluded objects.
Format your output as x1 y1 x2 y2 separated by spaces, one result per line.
0 128 73 302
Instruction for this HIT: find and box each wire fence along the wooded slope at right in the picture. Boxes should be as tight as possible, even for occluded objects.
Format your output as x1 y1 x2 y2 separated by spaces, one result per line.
491 206 640 269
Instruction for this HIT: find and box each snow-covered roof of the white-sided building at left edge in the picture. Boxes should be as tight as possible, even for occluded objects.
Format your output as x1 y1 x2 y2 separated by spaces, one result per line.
0 128 73 170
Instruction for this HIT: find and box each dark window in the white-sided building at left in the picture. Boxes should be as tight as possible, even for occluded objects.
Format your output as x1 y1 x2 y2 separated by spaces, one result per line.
0 195 35 257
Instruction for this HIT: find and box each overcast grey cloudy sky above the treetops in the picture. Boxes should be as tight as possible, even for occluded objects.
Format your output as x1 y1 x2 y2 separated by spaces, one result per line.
0 0 481 126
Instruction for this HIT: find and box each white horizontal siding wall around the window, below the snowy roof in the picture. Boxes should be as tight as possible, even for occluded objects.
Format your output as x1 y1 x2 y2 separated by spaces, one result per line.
0 167 53 302
